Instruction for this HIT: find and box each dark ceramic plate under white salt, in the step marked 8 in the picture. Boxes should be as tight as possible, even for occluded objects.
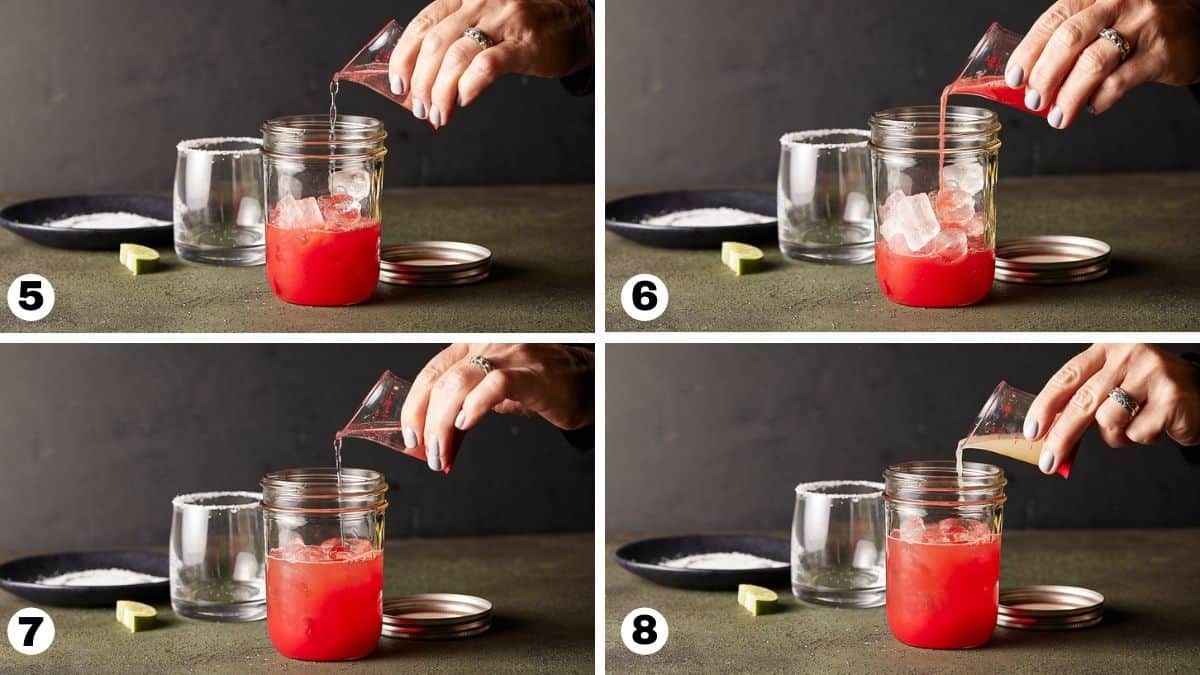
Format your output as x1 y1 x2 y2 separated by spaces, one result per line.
617 534 791 591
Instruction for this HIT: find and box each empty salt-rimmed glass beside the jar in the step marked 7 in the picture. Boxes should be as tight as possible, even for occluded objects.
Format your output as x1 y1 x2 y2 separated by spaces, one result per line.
170 492 266 621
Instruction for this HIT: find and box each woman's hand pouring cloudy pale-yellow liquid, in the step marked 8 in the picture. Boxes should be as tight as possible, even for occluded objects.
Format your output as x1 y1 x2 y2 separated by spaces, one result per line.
1025 345 1200 473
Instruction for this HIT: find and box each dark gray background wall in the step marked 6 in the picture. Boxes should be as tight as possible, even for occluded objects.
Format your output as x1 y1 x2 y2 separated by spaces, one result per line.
605 0 1200 187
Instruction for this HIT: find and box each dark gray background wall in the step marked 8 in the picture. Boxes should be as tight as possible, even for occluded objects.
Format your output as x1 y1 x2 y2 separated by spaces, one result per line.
605 345 1200 532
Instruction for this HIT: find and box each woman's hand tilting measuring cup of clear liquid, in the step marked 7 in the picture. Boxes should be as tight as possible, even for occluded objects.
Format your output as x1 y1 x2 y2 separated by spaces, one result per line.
400 345 595 472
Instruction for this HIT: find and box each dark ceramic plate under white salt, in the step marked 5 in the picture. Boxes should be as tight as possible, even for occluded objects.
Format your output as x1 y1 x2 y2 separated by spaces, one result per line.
0 195 175 251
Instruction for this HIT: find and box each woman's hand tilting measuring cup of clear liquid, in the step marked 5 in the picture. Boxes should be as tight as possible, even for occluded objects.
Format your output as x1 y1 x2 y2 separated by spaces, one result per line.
389 0 595 129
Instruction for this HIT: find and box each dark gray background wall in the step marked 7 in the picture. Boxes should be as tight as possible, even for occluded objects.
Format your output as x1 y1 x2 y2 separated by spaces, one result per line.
0 345 595 549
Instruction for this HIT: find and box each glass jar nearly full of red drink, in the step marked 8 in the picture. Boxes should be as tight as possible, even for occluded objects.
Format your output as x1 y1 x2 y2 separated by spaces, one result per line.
883 460 1007 649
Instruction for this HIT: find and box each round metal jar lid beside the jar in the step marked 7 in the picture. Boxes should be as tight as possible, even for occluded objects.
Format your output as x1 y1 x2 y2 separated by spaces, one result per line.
383 593 492 640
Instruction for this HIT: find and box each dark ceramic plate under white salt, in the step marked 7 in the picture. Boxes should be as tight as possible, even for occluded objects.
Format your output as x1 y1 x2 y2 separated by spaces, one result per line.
0 551 170 607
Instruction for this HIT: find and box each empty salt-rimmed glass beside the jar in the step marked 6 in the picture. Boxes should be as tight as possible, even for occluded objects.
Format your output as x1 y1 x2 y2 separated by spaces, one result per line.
776 129 875 264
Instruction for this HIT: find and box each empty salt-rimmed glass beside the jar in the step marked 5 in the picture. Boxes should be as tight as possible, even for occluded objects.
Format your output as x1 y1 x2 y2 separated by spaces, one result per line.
175 138 266 265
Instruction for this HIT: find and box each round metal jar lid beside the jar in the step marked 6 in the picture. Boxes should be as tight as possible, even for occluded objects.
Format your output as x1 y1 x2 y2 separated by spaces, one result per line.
996 235 1112 285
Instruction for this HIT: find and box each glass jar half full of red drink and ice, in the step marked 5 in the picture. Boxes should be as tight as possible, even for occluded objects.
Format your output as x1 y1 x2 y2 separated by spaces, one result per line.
263 115 388 306
